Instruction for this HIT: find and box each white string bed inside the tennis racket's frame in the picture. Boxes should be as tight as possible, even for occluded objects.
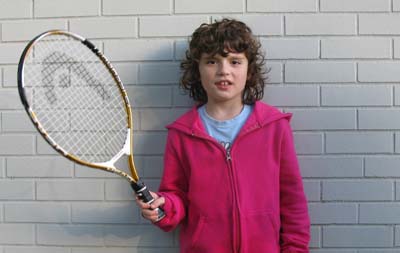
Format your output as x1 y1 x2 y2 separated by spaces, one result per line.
24 35 127 162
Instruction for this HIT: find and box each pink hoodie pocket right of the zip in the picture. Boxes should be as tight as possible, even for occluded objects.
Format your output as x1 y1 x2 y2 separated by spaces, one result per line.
242 211 279 253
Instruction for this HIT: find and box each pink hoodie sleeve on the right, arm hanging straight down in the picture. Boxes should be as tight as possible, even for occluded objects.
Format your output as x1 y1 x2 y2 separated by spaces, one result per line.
280 121 310 253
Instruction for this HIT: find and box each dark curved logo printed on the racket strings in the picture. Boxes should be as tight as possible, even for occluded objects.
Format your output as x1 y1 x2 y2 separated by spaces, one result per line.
41 51 110 104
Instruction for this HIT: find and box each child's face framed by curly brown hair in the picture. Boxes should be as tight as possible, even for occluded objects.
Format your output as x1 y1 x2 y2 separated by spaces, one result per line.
199 53 248 105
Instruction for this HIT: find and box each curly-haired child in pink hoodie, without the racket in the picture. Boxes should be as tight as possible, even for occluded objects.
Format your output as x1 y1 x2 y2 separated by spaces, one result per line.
137 19 310 253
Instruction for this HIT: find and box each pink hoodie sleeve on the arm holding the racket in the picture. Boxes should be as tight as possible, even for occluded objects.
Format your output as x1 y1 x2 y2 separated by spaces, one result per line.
155 130 187 231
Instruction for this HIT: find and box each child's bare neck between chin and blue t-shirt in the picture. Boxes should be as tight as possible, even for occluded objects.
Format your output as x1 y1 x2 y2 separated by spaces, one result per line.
206 103 244 121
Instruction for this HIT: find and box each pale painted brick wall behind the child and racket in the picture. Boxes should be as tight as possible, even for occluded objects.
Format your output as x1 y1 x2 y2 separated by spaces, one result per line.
0 0 400 253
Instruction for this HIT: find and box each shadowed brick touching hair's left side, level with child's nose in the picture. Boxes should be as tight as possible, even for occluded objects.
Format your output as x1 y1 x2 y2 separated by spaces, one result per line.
138 63 180 84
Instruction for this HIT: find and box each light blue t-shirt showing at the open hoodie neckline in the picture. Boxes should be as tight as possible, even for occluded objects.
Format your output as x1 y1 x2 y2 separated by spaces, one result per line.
198 105 253 150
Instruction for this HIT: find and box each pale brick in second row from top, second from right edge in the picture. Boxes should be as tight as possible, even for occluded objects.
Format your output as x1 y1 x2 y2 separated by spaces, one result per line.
286 14 357 35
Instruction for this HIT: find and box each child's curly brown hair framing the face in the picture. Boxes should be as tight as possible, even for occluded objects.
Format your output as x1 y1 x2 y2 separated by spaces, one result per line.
180 18 267 104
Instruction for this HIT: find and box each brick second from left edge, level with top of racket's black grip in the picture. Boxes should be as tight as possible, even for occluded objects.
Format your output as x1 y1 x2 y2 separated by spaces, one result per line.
36 180 104 200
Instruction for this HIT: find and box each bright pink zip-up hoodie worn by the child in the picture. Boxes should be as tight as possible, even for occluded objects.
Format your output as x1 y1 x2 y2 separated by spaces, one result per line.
156 102 310 253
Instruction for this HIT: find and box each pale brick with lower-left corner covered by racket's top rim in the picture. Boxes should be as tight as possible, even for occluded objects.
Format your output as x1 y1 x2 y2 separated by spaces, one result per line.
69 17 137 38
